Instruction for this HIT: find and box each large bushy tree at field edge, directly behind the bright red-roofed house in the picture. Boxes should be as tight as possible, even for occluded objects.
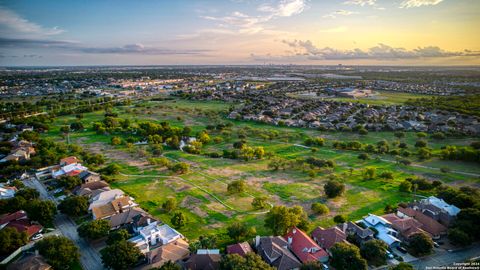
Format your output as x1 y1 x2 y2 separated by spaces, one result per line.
265 206 308 235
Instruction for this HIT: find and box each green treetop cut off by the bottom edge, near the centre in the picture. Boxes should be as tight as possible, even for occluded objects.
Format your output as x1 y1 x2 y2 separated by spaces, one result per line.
220 252 275 270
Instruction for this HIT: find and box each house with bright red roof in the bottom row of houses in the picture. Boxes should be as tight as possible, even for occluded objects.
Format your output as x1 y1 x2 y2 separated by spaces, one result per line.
284 227 328 263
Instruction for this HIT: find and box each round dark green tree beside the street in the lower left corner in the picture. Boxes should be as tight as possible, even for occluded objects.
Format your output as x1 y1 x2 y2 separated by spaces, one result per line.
35 236 80 269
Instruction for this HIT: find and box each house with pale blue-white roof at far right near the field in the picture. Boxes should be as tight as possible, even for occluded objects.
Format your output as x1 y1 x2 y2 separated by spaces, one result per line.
411 196 460 227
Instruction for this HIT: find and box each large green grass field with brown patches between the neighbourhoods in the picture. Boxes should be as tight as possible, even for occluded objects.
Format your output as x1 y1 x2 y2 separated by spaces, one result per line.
45 100 480 238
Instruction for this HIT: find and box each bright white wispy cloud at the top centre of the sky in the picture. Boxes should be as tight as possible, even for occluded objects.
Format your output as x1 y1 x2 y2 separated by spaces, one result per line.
200 0 306 34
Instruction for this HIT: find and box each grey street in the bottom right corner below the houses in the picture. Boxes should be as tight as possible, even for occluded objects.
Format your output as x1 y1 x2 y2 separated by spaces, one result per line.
410 243 480 270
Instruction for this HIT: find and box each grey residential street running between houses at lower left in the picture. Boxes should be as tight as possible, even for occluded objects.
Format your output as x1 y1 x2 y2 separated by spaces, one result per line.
24 177 104 270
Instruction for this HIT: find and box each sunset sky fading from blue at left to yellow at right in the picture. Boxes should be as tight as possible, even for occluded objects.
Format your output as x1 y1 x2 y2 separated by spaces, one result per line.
0 0 480 66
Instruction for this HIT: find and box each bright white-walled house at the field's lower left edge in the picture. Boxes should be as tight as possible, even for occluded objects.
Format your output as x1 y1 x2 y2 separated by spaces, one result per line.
128 221 185 254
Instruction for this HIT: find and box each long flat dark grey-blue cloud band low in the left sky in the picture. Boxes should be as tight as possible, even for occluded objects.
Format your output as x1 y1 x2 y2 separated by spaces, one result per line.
0 38 209 55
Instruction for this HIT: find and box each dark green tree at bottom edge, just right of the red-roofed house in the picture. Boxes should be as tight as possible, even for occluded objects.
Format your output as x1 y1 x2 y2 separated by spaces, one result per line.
330 242 367 270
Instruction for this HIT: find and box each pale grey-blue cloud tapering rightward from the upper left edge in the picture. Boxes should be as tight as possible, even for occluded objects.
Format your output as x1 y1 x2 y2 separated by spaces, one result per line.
0 7 64 37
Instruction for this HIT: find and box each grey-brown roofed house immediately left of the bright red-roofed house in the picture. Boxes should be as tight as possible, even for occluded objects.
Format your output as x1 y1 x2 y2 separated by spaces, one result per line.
255 236 302 270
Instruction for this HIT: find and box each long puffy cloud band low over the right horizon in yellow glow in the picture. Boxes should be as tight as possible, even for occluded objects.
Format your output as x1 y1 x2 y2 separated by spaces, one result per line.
282 40 480 60
